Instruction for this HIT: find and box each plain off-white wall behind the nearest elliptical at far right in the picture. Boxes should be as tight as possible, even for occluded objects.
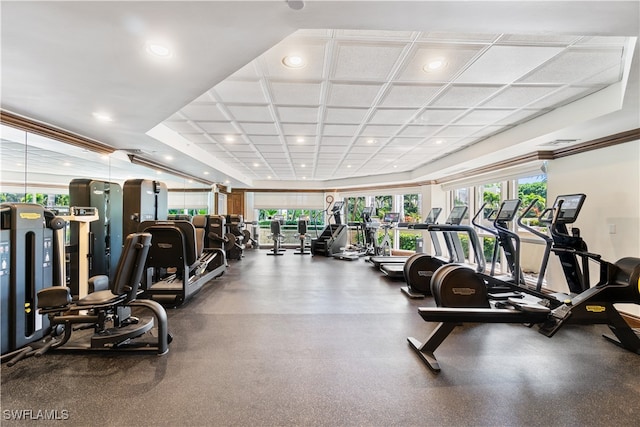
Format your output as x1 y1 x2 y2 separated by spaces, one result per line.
547 141 640 315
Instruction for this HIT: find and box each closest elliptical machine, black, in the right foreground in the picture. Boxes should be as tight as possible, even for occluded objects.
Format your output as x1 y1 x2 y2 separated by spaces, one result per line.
407 194 640 372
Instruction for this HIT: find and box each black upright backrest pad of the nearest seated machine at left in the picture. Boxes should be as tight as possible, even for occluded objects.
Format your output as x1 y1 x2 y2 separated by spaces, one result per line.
110 233 151 298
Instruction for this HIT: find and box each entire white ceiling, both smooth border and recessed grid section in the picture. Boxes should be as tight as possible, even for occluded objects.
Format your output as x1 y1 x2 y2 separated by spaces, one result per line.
1 1 640 188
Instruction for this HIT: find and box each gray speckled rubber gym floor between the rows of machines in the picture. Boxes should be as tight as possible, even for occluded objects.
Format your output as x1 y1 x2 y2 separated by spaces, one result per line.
0 250 640 426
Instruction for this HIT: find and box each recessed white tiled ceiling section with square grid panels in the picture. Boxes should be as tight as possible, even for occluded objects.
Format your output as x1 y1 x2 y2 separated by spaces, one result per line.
163 30 630 184
